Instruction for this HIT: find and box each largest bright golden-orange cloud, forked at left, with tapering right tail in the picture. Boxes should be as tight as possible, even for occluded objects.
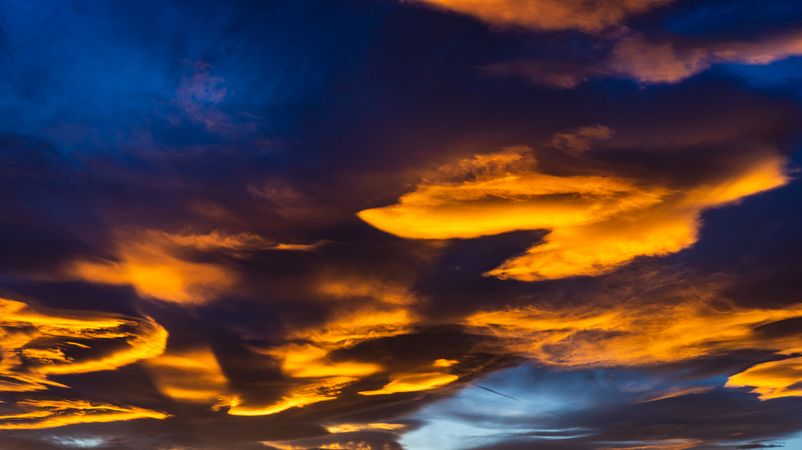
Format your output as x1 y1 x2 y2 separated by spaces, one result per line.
358 144 787 281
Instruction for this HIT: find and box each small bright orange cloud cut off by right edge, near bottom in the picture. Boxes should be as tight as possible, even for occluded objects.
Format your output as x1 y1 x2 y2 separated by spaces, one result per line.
727 356 802 400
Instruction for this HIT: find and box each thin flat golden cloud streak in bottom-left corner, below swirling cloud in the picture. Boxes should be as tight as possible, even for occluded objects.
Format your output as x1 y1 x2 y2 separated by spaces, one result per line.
0 400 169 430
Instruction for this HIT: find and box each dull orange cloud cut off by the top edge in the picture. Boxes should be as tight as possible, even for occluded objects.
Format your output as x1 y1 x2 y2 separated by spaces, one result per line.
406 0 671 32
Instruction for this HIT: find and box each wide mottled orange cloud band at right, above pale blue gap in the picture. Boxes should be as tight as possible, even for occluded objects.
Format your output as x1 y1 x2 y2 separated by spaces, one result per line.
466 300 802 367
